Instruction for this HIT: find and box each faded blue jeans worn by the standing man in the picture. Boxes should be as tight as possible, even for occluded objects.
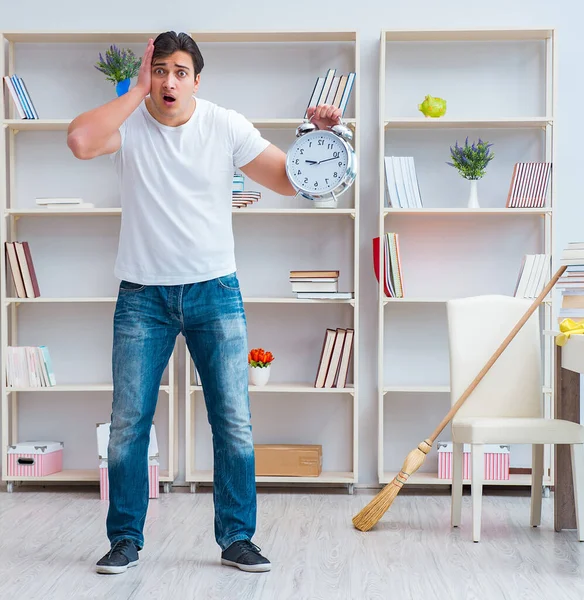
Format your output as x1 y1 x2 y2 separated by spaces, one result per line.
106 273 256 550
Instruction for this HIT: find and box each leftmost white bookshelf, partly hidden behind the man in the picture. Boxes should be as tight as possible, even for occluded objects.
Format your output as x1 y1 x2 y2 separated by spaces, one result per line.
0 32 189 492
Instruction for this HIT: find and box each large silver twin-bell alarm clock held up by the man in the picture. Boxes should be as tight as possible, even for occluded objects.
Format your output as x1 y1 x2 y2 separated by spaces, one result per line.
286 120 357 207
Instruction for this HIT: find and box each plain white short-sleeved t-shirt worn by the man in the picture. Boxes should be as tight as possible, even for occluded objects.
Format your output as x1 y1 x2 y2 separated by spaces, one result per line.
112 97 269 285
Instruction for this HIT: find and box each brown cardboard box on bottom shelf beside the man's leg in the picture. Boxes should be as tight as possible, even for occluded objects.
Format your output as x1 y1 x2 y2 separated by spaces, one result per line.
254 444 322 477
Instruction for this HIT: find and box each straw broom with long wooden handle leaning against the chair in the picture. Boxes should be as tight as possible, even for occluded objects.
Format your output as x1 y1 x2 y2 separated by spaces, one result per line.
353 265 566 531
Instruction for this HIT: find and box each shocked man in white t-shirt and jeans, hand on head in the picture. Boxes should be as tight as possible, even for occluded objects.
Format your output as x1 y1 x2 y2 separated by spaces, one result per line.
67 32 340 573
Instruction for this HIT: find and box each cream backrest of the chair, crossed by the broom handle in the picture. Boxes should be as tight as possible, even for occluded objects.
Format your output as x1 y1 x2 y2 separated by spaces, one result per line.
446 295 543 422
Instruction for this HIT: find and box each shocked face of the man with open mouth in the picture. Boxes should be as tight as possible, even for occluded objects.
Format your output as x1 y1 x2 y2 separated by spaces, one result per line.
150 51 200 121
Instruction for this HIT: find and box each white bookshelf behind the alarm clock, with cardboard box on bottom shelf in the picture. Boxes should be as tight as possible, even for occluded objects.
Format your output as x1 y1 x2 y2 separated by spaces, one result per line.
184 31 360 493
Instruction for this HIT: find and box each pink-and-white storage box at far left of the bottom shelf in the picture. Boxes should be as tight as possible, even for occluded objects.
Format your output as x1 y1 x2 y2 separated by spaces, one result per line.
8 442 64 477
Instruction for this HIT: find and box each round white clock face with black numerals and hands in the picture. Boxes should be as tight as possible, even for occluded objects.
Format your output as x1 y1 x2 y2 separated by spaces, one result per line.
286 130 349 194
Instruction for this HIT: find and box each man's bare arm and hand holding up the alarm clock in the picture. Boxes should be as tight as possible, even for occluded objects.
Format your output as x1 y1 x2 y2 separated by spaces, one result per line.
240 104 341 196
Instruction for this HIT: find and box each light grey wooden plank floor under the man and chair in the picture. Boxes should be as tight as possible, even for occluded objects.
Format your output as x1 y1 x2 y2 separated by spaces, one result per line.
0 488 584 600
